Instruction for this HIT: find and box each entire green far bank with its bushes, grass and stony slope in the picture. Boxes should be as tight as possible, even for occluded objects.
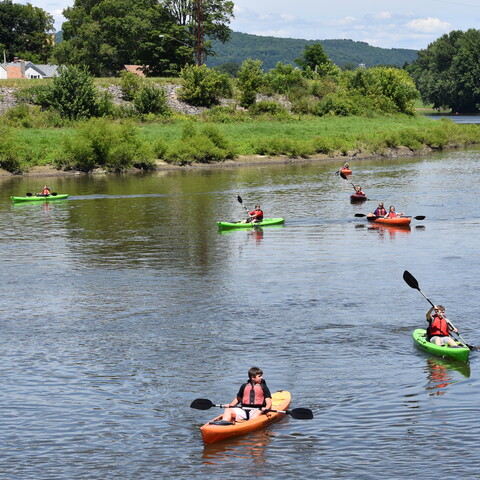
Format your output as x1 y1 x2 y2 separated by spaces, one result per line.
0 59 480 173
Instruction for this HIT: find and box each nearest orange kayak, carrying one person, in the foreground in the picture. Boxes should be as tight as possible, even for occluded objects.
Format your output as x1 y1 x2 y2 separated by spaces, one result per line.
200 390 291 445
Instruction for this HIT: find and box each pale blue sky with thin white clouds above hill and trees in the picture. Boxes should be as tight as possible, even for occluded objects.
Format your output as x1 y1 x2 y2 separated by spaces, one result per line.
25 0 480 50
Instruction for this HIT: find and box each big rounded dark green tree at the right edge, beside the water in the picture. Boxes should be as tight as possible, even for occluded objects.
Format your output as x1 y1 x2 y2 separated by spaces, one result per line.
407 29 480 113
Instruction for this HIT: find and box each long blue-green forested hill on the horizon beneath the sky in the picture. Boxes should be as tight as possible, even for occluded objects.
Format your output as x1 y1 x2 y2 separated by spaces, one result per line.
206 32 417 70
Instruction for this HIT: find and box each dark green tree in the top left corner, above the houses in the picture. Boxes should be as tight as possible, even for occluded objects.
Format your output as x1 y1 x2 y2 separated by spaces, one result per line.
0 0 54 63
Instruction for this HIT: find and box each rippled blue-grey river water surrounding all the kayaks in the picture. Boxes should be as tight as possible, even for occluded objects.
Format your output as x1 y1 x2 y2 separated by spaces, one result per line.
0 150 480 480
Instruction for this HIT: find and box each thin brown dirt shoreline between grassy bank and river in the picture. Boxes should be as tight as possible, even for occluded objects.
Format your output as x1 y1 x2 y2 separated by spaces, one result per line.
0 147 433 177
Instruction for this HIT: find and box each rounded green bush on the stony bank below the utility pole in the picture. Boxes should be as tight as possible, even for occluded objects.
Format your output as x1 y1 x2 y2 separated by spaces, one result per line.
178 65 232 107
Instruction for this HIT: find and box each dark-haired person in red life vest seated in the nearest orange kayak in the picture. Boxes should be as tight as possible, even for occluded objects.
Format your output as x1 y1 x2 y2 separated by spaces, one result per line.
222 367 272 422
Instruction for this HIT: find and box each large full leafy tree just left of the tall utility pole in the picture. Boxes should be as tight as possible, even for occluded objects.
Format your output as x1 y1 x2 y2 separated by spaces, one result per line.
54 0 186 76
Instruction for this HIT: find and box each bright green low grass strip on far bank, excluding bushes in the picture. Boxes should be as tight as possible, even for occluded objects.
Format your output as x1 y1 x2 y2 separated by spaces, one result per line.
3 115 480 170
